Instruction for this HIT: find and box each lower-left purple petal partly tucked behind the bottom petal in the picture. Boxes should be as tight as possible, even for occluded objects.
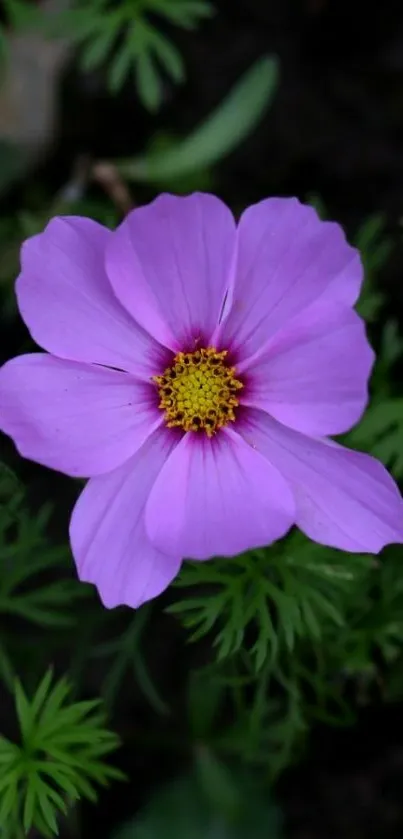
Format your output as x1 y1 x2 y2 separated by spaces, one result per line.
70 432 181 608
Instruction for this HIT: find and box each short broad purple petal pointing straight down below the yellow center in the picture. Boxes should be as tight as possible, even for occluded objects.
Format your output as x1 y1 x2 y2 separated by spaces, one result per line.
146 431 295 559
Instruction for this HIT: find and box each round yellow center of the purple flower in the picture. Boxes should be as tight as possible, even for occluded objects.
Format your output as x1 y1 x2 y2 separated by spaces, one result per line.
153 347 243 437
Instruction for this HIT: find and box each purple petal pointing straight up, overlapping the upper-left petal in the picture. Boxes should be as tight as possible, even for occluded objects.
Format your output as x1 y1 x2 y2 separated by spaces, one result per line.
106 193 236 350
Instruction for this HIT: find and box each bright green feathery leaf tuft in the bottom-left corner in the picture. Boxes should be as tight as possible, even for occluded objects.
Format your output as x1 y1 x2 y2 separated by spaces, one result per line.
0 671 123 839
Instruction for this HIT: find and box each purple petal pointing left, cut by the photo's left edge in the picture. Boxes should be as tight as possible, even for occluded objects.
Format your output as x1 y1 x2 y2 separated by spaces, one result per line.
0 353 162 477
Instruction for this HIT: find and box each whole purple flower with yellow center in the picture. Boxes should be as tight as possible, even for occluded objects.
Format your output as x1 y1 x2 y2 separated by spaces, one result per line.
0 194 403 607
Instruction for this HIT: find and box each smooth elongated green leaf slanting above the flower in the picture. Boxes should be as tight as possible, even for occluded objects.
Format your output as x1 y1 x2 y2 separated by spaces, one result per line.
116 57 278 182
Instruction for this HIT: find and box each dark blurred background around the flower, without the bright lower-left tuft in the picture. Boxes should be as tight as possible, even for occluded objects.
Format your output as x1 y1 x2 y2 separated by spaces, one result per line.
0 0 403 839
